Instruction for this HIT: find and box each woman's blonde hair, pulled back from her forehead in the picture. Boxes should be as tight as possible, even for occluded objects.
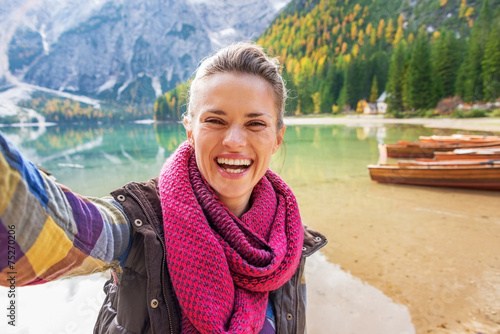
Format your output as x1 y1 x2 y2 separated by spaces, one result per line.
183 42 287 130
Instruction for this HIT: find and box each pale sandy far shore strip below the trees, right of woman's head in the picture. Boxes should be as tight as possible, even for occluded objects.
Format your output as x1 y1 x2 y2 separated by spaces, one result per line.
285 115 500 132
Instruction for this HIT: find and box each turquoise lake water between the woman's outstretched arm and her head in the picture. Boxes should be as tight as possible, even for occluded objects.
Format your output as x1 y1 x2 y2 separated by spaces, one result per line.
2 123 184 196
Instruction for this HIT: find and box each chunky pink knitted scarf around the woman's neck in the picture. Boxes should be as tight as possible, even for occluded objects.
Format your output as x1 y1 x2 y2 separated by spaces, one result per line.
159 142 304 333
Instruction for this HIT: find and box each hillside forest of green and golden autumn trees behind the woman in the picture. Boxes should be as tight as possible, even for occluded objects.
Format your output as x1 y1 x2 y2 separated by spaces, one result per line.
155 0 500 119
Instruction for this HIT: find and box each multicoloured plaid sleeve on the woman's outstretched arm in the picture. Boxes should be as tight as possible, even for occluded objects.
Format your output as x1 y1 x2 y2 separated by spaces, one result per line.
0 133 130 286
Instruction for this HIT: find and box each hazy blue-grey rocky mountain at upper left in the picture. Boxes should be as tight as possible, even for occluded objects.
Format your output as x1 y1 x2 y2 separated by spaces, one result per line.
0 0 289 104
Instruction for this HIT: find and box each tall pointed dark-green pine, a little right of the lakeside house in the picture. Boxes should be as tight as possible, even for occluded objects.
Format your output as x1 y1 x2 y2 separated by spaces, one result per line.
408 27 435 109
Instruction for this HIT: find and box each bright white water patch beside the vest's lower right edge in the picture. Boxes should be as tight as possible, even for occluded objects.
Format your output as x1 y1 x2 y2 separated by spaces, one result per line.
306 252 415 334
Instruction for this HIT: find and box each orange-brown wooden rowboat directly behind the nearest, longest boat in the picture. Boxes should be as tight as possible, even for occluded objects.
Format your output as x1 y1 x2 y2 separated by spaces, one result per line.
385 141 500 158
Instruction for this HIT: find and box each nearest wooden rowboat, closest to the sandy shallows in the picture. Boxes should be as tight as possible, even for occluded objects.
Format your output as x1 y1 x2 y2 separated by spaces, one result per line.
368 160 500 190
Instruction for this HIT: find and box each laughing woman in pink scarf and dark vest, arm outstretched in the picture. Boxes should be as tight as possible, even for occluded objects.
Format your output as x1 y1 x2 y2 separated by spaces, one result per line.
0 43 326 333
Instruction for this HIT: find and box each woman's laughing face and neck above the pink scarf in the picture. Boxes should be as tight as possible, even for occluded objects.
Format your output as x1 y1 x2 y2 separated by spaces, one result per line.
185 72 285 216
